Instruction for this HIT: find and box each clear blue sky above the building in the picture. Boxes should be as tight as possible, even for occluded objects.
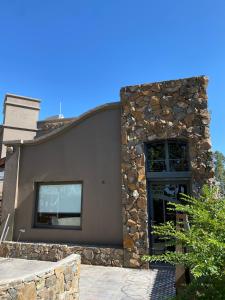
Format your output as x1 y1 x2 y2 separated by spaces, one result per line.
0 0 225 154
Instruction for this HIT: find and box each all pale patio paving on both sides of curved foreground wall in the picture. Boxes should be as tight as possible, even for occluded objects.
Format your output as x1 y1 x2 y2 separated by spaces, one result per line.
0 258 175 300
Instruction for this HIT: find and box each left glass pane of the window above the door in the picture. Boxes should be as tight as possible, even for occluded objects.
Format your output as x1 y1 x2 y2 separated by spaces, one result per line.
147 143 166 172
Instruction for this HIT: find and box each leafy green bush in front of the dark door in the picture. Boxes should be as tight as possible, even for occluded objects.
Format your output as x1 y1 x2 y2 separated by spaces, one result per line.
143 186 225 299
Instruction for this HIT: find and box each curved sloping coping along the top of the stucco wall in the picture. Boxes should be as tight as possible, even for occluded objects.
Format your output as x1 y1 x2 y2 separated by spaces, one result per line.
3 102 120 146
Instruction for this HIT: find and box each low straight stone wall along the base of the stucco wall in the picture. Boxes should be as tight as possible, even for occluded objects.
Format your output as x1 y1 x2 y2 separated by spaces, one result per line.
0 242 123 267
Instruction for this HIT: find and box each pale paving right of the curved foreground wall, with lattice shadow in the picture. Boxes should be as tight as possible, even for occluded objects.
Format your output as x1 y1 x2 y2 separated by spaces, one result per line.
80 265 175 300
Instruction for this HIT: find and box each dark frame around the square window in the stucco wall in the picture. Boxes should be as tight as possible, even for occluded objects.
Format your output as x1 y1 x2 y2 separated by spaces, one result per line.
32 181 84 230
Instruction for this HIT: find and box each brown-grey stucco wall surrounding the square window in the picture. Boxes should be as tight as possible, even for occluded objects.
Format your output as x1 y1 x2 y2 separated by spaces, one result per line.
14 105 122 245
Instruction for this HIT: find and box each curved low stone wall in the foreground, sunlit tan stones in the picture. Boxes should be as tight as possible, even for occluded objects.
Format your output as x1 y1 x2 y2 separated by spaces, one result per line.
0 254 80 300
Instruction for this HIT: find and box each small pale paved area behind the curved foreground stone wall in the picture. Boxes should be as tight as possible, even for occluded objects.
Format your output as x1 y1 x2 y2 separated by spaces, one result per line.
0 258 54 283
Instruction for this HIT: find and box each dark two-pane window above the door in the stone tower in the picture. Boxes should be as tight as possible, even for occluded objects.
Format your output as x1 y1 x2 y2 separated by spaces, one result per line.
147 140 189 172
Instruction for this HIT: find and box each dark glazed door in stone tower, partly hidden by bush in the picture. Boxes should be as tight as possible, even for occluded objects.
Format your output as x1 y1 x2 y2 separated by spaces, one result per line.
148 180 188 255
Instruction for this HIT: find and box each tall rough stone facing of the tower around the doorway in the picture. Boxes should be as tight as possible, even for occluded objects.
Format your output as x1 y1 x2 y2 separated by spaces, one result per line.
121 76 213 268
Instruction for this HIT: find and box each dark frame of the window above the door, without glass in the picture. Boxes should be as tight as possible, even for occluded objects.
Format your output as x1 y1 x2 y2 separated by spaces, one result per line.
145 138 191 180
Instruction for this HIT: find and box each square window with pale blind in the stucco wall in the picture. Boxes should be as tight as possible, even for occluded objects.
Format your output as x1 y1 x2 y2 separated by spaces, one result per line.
35 183 82 227
